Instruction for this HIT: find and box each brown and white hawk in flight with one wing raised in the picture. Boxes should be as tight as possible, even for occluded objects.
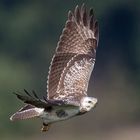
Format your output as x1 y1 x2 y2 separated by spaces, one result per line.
10 4 99 131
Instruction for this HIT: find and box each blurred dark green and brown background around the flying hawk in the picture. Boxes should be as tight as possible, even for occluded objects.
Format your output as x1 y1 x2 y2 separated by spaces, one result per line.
0 0 140 140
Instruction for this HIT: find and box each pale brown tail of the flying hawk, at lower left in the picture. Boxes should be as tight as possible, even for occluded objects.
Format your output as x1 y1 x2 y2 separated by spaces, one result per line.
10 105 44 121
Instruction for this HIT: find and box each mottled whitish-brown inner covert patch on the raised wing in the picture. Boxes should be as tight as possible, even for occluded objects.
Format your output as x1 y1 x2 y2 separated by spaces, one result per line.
53 55 95 100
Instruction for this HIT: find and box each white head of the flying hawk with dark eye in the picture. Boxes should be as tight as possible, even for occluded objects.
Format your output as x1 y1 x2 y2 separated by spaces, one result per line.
80 97 97 112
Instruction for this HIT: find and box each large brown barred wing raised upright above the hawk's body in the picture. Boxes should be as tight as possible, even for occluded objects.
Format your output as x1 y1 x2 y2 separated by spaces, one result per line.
47 4 99 104
